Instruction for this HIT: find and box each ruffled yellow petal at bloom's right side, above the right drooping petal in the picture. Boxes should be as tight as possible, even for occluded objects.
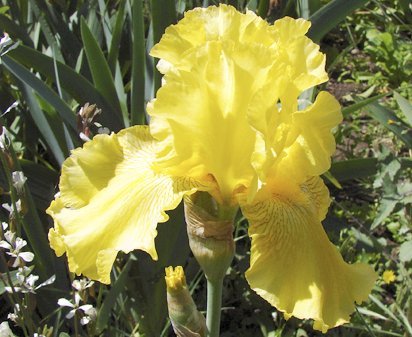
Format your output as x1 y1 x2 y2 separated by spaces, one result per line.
252 92 342 192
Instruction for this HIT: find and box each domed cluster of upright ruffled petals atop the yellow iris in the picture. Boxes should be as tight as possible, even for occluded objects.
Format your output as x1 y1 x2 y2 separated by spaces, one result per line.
148 4 336 203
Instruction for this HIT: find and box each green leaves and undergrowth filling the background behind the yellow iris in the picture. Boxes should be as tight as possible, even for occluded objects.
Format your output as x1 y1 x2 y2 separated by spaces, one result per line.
0 0 412 337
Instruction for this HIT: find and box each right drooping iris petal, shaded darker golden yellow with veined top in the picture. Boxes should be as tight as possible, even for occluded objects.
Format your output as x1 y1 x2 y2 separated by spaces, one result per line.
242 177 376 332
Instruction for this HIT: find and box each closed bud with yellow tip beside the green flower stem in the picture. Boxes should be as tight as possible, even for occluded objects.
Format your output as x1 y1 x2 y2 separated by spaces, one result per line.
165 266 207 337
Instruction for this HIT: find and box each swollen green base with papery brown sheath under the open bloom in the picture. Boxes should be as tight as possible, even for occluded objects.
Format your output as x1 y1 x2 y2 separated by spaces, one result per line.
184 192 237 281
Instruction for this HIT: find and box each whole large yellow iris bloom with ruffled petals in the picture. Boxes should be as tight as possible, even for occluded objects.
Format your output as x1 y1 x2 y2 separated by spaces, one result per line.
47 5 376 331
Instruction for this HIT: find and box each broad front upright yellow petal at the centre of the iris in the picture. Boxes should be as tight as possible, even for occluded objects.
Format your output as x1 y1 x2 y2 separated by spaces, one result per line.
148 42 275 203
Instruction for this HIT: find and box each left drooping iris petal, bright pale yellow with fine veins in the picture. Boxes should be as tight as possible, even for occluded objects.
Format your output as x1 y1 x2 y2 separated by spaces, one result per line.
47 126 206 283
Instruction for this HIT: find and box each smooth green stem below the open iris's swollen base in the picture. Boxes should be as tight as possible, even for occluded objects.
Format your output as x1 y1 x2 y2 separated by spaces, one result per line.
206 278 223 337
